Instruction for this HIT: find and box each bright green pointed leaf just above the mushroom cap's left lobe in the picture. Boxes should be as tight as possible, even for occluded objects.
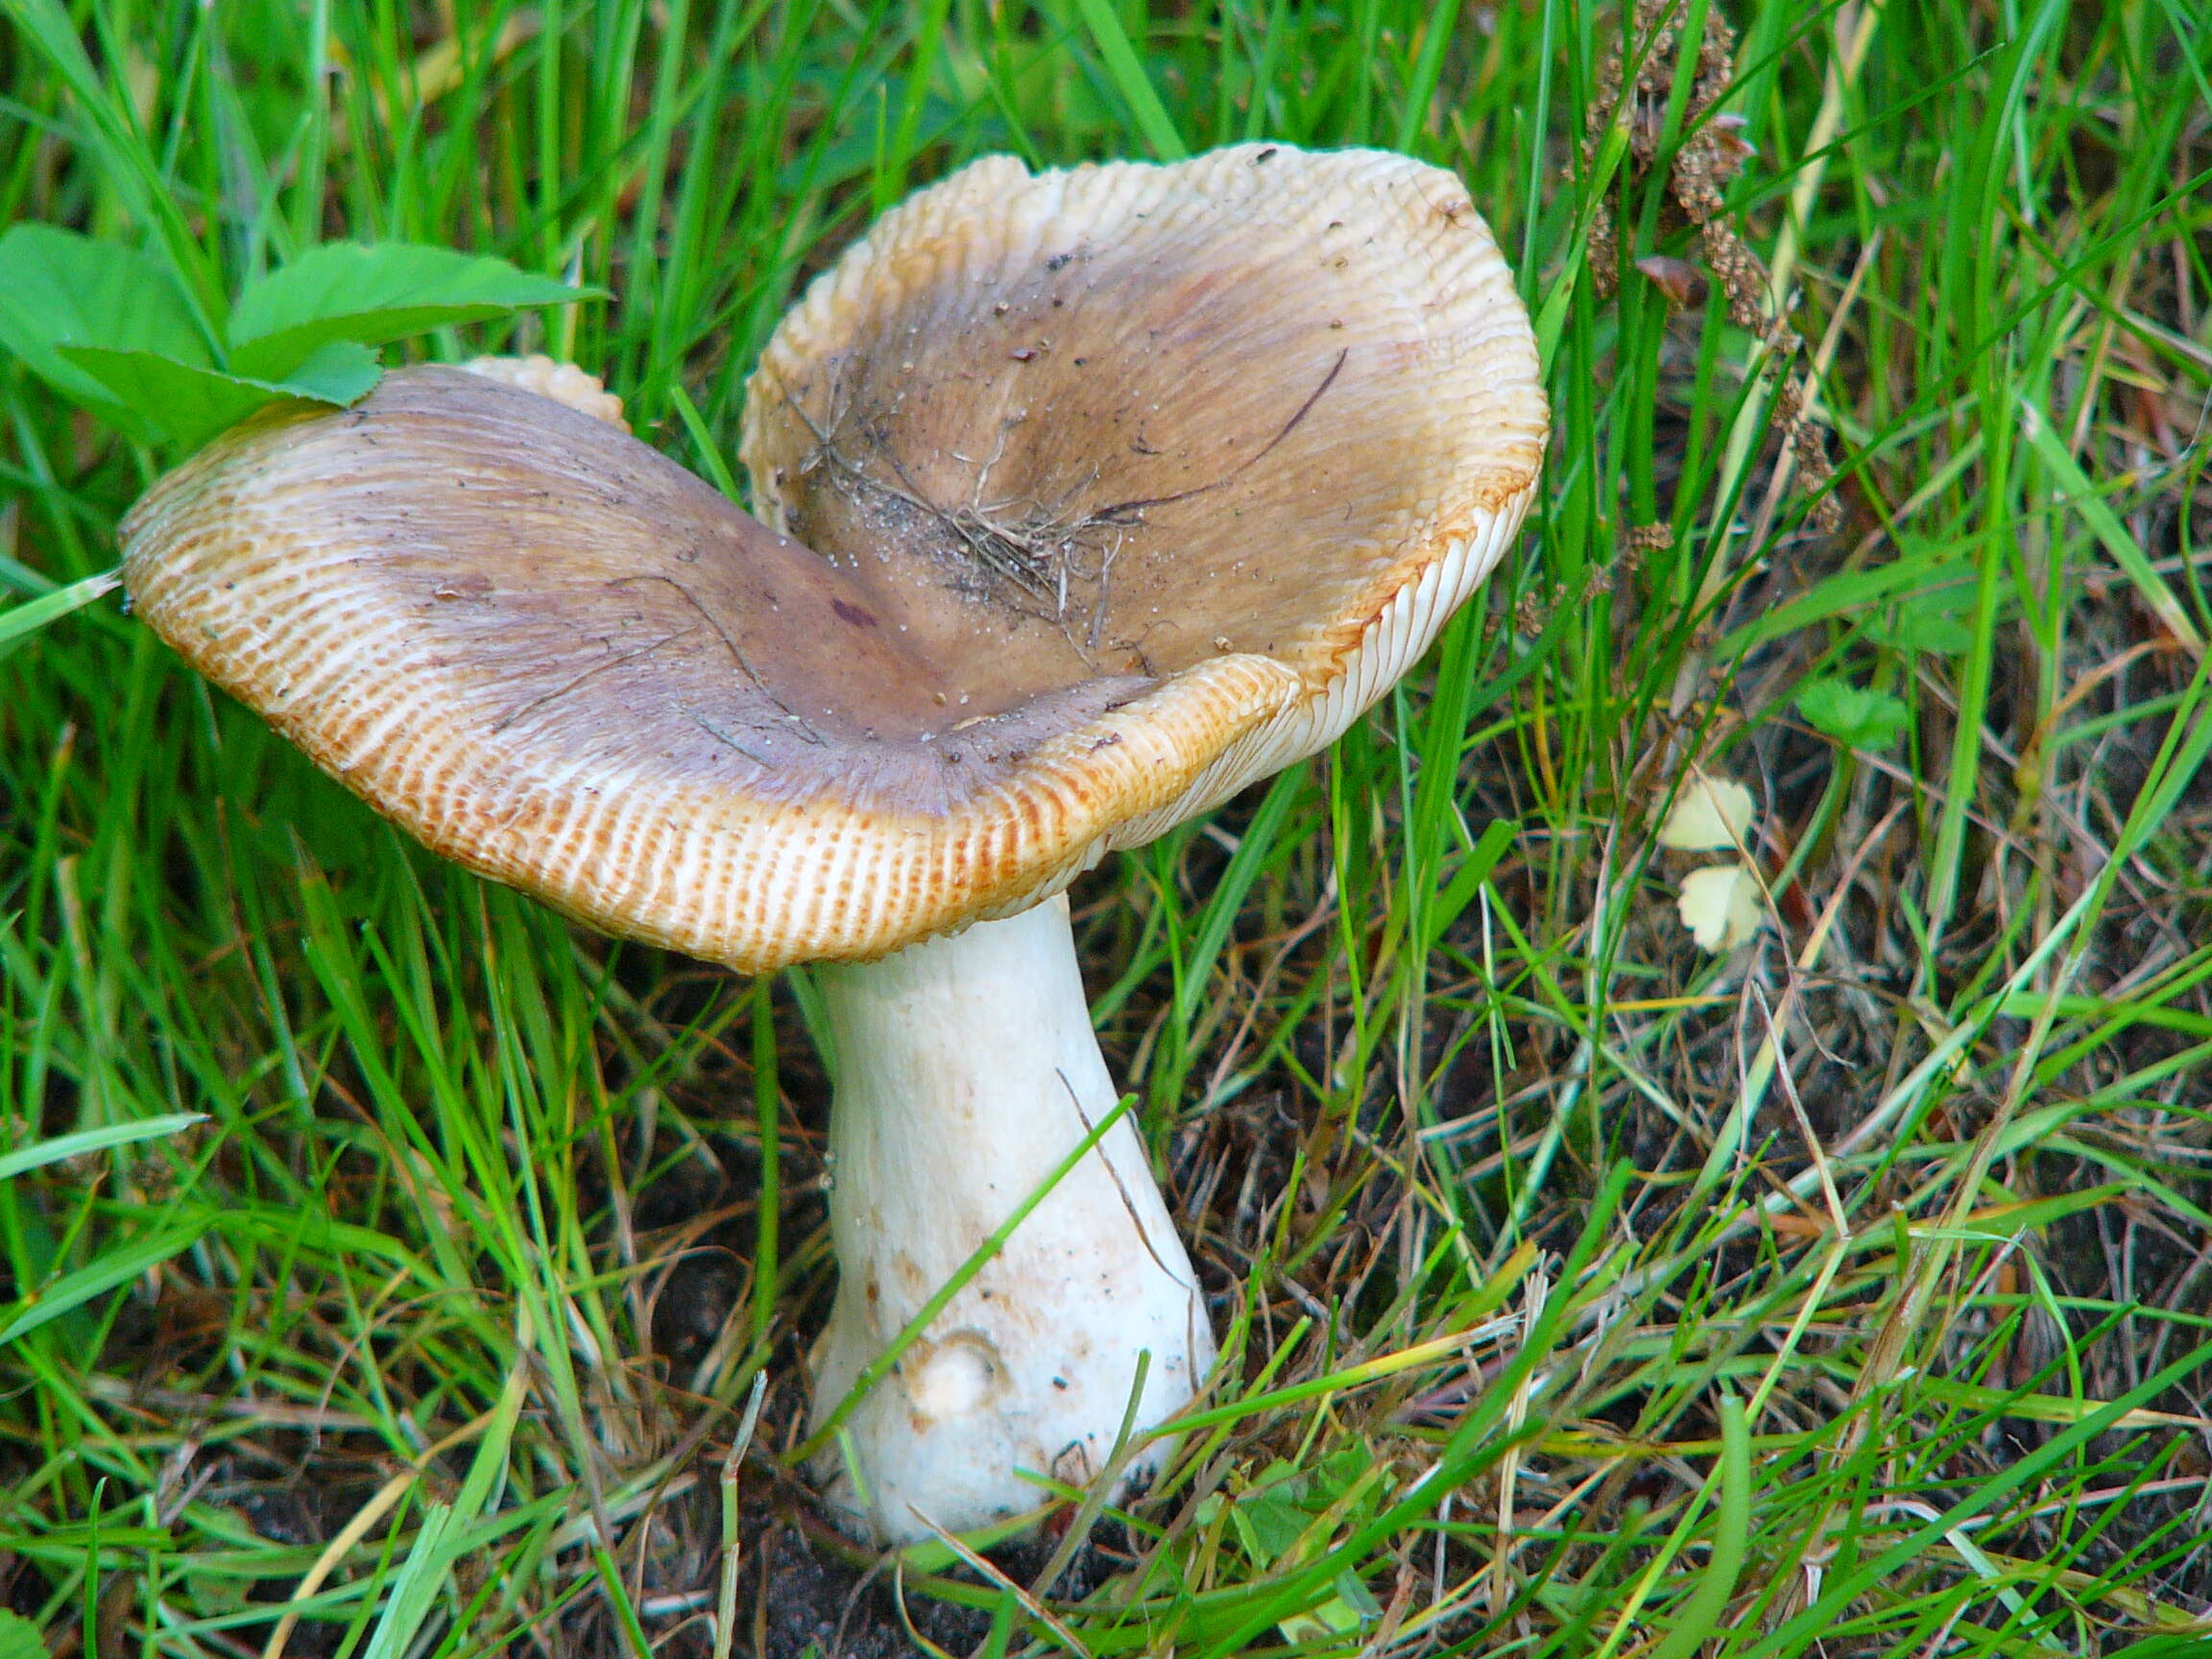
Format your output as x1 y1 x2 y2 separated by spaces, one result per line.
230 241 602 378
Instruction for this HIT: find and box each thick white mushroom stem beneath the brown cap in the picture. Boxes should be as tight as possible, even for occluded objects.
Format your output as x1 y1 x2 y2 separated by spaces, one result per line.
814 898 1214 1542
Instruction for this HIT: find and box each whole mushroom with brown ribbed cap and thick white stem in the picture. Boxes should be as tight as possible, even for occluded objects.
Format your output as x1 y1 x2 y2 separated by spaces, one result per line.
124 146 1546 1542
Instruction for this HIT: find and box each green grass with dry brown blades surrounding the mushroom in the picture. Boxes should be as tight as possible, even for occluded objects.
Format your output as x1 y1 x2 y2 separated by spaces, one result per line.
0 0 2212 1659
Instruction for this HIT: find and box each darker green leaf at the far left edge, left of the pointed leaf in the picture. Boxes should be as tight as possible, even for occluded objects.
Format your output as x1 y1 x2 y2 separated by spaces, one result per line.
0 224 214 438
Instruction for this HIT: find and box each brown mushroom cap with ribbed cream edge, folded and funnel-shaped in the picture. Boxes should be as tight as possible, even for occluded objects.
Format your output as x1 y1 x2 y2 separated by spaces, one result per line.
124 146 1546 971
